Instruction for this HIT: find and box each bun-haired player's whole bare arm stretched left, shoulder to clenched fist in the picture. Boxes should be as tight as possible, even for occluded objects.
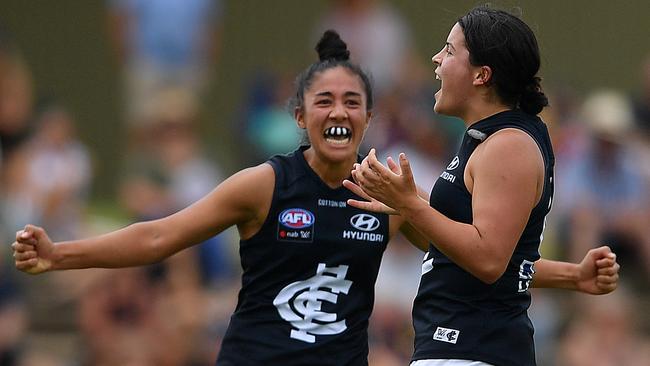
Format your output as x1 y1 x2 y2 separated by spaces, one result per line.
12 164 274 274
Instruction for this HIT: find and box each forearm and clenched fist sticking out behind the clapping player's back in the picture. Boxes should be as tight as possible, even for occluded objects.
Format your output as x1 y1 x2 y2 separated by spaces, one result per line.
532 246 620 295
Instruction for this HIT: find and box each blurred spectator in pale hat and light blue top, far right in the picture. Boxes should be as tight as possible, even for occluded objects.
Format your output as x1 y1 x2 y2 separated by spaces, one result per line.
556 91 650 283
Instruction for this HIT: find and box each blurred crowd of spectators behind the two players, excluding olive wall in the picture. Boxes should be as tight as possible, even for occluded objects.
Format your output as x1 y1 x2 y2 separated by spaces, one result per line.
0 0 650 366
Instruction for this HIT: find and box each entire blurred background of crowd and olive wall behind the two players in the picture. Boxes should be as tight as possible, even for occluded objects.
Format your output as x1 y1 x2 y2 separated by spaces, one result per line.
0 0 650 366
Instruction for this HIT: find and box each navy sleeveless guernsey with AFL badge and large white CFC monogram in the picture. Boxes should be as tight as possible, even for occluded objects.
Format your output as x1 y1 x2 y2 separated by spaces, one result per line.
217 147 389 366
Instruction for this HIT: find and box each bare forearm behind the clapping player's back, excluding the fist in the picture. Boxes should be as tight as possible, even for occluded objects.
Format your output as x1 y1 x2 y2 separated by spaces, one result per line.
532 259 579 290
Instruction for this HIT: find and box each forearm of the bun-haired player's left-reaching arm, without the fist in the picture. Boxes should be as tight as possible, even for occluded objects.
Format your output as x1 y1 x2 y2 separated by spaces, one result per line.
52 222 173 270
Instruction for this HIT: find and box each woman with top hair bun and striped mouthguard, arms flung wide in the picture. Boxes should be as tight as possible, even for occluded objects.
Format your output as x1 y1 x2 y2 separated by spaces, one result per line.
13 31 427 366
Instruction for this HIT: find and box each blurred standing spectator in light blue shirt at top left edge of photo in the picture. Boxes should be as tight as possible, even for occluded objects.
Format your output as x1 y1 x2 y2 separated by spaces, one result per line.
108 0 222 138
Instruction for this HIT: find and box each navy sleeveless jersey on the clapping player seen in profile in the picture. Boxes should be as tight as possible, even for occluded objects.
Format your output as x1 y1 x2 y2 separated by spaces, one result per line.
413 110 555 366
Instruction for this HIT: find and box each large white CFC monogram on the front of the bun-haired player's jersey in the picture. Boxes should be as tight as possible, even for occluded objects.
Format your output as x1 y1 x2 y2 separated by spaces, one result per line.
273 263 352 343
